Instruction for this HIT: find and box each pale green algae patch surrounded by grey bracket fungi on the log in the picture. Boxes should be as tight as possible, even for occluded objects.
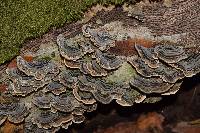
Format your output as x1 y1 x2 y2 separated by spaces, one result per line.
106 62 136 83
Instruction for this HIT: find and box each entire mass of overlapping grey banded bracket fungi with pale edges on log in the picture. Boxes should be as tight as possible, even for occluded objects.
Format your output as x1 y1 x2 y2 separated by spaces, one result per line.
0 25 200 132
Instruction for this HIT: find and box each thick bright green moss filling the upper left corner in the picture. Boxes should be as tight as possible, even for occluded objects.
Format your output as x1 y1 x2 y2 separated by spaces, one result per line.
0 0 124 64
